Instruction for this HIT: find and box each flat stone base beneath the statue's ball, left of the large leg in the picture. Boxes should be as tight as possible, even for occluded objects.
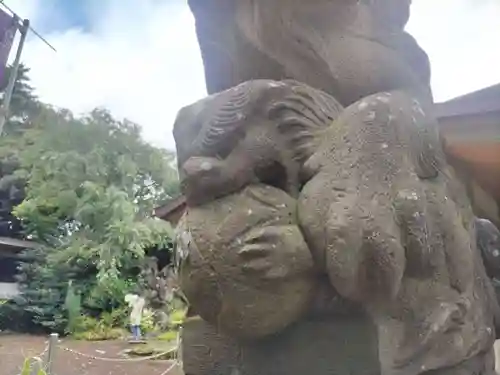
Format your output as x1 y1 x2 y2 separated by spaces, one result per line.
182 316 380 375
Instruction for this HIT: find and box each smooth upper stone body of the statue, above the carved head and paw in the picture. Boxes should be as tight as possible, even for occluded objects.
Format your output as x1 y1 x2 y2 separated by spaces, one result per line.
189 0 430 105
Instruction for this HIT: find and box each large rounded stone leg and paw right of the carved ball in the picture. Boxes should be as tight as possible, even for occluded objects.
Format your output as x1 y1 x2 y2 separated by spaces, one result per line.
299 92 497 374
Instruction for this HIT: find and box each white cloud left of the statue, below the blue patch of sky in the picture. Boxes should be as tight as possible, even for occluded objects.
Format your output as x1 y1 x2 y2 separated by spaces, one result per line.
7 0 205 149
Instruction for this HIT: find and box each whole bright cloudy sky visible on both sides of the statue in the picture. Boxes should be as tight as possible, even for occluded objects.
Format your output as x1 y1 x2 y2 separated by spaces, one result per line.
5 0 500 149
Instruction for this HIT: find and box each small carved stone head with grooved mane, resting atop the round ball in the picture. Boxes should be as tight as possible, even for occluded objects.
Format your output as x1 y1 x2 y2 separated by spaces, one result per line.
174 80 342 205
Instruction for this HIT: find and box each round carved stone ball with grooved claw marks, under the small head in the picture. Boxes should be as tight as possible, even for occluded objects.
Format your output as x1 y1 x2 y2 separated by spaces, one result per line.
178 185 316 339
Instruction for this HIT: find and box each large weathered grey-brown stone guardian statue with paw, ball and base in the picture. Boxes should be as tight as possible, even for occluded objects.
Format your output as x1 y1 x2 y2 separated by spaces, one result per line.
174 0 499 375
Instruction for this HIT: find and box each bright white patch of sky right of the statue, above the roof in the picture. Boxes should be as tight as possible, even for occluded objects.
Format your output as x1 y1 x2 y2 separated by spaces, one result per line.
408 0 500 101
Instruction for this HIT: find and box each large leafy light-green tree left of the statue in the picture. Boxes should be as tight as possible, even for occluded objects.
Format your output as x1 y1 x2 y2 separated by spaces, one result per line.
9 106 178 330
